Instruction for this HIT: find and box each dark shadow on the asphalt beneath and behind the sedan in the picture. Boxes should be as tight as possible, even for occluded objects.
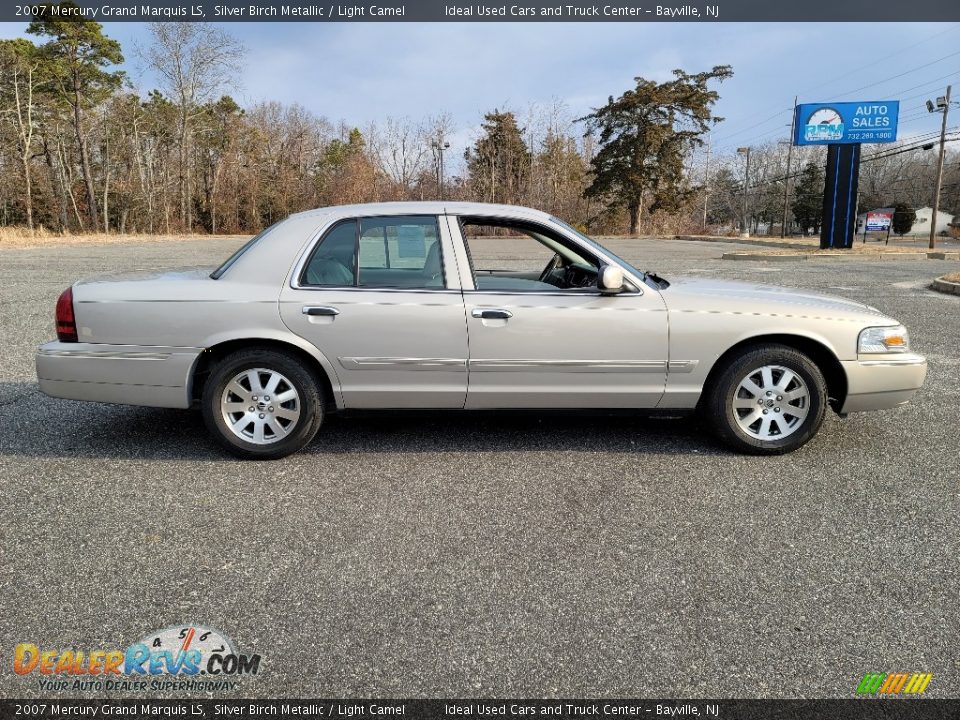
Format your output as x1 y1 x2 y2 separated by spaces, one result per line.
0 383 728 460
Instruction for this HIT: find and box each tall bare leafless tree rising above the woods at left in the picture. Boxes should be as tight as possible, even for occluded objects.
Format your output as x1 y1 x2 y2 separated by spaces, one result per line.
137 22 243 230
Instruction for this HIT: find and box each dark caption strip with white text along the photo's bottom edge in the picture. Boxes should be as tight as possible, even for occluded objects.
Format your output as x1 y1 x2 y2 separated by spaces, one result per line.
0 698 960 720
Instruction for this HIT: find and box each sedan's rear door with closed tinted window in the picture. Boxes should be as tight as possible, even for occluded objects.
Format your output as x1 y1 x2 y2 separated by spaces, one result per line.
280 215 467 408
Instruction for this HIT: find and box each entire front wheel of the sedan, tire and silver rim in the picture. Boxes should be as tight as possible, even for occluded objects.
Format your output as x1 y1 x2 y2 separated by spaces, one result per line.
702 344 827 455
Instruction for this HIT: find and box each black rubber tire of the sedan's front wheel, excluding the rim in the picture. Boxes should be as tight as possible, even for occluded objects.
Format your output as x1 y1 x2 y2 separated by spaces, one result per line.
709 345 827 455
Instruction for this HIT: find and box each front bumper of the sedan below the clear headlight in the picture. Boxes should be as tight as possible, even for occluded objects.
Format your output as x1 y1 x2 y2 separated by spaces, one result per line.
840 355 927 413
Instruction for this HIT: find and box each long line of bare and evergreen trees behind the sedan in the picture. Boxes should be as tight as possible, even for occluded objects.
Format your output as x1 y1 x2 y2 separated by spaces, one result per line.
0 8 960 238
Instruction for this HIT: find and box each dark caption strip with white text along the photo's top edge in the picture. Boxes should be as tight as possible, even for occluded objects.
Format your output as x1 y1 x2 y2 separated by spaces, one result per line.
7 0 960 22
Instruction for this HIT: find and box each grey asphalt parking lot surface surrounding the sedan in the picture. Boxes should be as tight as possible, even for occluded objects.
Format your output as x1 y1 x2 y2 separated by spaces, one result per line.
0 241 960 698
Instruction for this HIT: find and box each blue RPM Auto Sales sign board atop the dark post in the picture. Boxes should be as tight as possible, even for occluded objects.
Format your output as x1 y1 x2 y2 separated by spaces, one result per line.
793 100 900 145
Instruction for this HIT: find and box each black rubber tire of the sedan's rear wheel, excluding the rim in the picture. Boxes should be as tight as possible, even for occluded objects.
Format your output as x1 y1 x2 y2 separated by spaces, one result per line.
201 349 324 460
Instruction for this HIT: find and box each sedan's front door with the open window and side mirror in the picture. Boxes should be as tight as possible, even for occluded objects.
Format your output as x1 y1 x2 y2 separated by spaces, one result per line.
450 218 668 408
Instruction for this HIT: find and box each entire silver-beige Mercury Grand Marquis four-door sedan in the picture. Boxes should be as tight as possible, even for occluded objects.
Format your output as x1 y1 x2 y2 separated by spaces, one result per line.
37 202 927 458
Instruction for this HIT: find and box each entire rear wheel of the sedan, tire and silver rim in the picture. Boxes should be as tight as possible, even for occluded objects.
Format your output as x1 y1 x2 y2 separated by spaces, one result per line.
201 348 324 460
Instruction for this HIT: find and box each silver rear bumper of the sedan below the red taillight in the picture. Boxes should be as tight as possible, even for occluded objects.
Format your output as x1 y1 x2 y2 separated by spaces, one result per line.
37 342 203 408
